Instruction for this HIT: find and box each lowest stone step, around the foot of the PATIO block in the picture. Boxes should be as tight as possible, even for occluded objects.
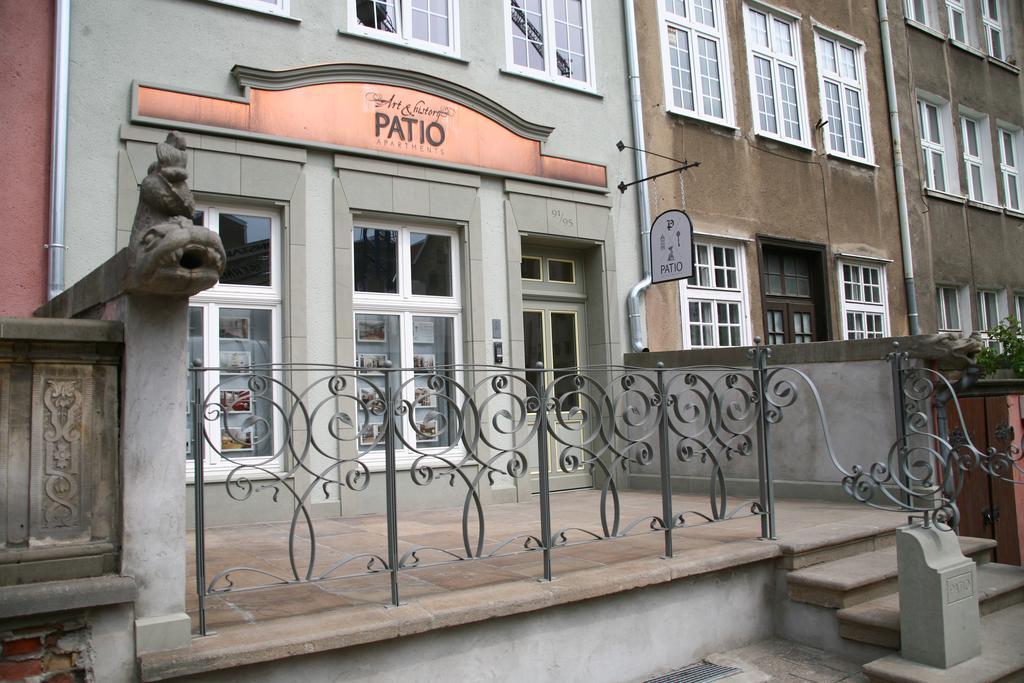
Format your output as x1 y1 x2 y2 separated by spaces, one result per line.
863 604 1024 683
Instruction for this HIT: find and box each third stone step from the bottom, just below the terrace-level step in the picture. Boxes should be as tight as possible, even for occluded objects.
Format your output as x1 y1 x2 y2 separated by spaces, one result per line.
786 537 995 609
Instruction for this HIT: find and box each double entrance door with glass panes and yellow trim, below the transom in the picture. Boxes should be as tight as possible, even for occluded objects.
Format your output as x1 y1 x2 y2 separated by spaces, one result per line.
522 300 594 493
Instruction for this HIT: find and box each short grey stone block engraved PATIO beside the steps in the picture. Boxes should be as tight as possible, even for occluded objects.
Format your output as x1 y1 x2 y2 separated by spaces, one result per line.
896 526 981 669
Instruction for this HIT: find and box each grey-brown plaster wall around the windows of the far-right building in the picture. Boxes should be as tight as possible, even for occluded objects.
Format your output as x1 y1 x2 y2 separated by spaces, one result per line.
889 2 1024 333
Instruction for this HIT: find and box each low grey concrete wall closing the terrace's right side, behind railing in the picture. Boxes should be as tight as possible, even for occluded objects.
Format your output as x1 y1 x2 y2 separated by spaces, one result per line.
626 339 896 501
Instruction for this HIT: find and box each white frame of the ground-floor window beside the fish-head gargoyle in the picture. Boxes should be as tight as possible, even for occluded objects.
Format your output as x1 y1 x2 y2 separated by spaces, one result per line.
185 202 286 481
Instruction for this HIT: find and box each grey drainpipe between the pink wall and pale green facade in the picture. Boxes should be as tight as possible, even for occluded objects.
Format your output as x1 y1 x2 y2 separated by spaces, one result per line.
46 0 71 299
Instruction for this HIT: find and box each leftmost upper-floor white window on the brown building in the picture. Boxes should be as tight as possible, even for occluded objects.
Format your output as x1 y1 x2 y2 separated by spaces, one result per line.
659 0 733 125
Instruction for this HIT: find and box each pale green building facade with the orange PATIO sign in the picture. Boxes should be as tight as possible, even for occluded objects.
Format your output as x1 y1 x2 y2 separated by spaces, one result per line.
58 0 639 519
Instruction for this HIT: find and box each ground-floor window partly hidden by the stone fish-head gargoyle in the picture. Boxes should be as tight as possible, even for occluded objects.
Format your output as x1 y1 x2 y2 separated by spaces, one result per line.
186 206 281 472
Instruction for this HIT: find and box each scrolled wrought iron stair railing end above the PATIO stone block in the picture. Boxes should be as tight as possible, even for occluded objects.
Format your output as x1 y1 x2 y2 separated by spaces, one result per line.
819 344 1024 530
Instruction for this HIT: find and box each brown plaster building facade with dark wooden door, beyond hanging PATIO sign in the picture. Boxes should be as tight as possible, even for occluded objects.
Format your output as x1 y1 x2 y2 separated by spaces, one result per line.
638 0 907 350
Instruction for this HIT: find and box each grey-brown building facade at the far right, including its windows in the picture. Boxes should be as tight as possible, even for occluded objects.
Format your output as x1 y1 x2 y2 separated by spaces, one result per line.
890 0 1024 334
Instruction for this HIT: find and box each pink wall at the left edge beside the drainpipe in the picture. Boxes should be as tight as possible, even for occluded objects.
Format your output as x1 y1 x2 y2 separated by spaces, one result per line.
0 0 53 315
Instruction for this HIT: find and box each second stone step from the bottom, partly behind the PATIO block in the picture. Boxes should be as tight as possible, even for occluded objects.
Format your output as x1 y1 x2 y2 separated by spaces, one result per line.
836 562 1024 650
